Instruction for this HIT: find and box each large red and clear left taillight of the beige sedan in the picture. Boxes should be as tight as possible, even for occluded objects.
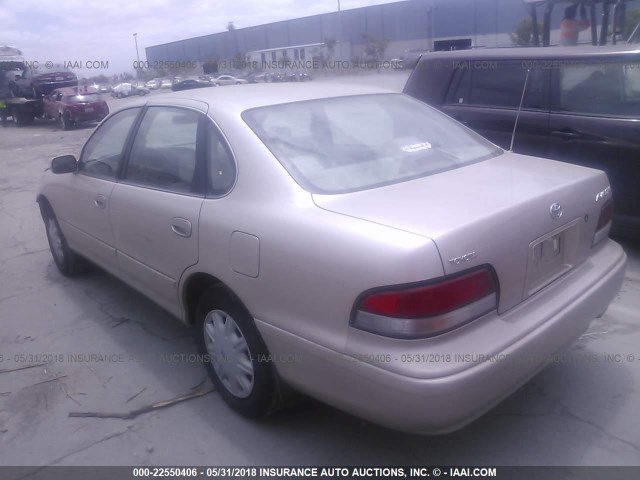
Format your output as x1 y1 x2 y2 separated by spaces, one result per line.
351 267 498 338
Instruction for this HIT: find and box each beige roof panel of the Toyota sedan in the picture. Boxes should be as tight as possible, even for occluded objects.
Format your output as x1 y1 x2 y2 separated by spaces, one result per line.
147 82 397 113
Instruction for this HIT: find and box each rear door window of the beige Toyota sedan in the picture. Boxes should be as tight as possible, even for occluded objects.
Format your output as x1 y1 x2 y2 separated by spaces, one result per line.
125 107 200 193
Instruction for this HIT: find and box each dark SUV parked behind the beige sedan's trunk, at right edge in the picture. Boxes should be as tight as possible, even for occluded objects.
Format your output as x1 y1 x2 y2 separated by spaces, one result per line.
404 45 640 236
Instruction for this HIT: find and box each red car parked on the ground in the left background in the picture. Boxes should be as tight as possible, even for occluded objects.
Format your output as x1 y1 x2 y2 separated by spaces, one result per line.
44 87 109 130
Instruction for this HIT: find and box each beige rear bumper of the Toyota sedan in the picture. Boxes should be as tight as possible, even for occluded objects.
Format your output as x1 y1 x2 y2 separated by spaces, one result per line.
256 240 626 433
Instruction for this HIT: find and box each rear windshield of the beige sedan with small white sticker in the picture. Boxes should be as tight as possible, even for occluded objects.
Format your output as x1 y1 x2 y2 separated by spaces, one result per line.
242 94 502 194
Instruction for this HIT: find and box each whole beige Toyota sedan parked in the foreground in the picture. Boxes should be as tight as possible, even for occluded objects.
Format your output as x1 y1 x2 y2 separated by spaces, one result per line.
38 84 626 433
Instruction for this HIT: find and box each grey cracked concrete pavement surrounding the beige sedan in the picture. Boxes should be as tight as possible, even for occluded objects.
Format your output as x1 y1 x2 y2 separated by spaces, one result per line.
0 73 640 466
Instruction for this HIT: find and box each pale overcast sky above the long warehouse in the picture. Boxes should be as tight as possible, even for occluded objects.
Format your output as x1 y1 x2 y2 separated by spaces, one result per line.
0 0 404 76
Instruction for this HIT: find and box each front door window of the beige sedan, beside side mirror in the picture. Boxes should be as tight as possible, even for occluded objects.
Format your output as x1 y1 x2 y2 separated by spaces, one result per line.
78 108 140 179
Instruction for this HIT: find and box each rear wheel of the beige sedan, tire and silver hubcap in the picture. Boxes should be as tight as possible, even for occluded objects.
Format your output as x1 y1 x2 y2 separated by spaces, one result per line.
196 286 278 418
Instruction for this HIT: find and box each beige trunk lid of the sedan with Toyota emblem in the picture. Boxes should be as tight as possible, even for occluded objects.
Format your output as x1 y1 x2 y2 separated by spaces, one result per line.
313 153 608 312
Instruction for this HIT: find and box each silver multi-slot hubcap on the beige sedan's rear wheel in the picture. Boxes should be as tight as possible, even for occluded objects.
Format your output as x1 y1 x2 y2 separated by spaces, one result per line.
203 310 254 398
